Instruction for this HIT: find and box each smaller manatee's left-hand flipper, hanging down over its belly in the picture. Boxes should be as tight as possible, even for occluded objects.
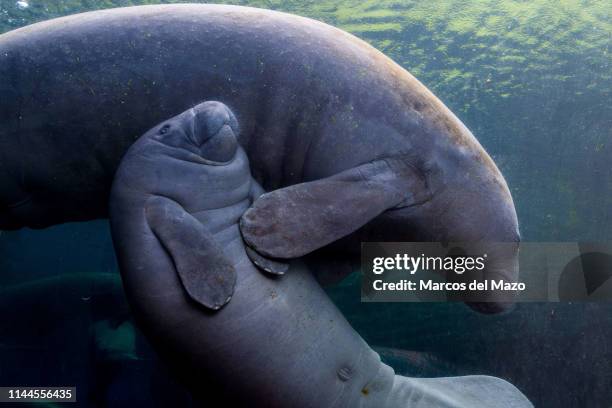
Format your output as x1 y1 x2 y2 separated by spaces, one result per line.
145 196 236 310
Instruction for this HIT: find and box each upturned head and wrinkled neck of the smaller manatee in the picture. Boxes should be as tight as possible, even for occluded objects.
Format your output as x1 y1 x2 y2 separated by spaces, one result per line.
115 101 252 233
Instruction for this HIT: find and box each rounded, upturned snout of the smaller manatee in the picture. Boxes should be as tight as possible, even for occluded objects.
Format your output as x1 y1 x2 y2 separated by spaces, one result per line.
187 102 238 166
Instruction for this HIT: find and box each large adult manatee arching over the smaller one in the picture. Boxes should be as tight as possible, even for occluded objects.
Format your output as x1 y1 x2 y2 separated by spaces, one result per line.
0 5 519 258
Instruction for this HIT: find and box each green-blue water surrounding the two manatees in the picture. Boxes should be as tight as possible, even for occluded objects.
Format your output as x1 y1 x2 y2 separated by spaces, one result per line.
0 0 612 407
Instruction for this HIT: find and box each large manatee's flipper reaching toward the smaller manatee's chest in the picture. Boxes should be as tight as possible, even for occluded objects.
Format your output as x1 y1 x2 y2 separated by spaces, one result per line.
240 158 429 259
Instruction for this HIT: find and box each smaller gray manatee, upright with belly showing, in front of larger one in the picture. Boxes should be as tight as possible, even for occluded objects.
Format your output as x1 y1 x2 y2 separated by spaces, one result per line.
110 102 530 408
